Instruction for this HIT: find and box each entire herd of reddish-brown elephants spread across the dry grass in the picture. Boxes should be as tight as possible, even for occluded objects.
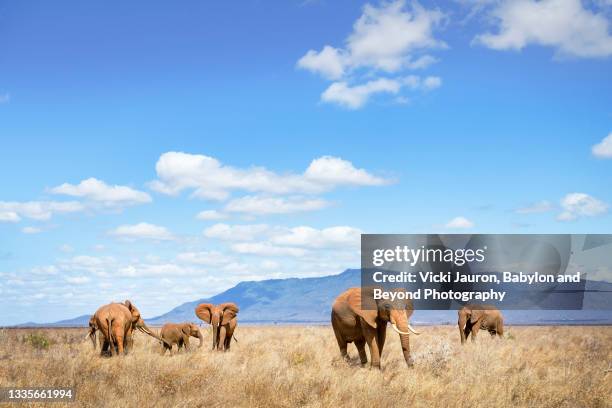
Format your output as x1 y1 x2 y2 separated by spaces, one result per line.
87 288 504 368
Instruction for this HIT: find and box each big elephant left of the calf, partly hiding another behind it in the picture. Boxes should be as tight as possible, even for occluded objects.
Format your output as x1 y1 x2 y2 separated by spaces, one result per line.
89 300 161 356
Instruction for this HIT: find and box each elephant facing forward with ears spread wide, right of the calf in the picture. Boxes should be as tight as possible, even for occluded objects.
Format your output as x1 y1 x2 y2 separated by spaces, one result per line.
195 302 239 351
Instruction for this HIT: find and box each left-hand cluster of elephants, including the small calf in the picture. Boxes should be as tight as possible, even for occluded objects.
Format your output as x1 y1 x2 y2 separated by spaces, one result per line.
87 300 239 356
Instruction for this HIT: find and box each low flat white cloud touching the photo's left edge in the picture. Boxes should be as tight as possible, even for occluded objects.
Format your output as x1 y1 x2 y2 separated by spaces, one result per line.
0 201 85 222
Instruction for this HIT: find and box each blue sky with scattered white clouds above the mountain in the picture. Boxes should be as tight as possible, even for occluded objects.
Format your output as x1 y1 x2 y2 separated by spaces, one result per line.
0 0 612 324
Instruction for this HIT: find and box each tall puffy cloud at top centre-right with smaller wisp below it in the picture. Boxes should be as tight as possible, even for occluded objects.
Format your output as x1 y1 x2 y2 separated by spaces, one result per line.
297 0 446 109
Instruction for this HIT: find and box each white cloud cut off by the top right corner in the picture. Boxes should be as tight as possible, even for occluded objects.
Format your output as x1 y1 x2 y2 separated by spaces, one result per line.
474 0 612 58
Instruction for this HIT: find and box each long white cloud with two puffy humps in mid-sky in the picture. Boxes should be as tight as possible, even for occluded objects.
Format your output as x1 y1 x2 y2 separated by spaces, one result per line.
150 152 390 200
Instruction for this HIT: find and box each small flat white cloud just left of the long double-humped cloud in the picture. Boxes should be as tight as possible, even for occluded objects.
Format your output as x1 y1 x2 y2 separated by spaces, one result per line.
50 177 152 207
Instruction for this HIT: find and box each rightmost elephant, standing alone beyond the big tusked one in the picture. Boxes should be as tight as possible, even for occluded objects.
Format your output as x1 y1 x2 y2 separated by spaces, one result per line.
457 305 504 344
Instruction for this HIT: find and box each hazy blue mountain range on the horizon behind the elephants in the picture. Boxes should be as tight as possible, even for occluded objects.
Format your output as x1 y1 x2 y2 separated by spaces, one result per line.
13 269 612 327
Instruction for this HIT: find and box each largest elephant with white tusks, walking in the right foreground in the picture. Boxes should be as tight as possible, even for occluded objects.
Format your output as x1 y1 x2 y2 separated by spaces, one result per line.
331 288 420 369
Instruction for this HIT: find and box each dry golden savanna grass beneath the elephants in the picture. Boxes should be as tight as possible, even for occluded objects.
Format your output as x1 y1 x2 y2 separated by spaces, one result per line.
0 326 612 408
